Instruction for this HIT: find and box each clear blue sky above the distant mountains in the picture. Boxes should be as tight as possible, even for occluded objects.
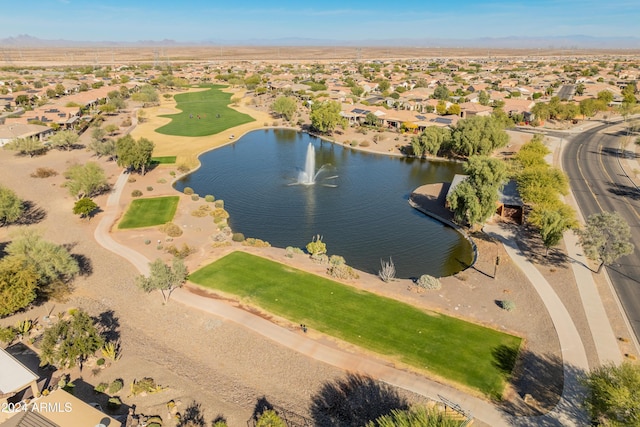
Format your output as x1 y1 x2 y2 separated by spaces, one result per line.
0 0 640 42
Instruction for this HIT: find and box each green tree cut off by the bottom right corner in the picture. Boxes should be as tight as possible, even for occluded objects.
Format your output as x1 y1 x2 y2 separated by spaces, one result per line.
582 361 640 427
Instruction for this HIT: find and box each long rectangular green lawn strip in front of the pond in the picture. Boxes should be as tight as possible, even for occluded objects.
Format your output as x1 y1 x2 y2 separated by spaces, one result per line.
189 252 521 398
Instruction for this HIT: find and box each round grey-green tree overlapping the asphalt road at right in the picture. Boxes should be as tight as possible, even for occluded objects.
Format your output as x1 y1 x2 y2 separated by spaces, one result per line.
578 212 634 273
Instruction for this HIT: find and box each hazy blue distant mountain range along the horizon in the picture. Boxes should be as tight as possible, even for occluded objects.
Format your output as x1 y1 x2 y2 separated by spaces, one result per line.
0 34 640 49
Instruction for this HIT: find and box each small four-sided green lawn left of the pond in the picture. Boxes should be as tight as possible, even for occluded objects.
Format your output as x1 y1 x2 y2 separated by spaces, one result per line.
118 196 180 228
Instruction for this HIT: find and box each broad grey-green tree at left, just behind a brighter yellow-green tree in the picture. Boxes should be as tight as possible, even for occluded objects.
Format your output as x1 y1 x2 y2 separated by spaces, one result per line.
6 230 80 286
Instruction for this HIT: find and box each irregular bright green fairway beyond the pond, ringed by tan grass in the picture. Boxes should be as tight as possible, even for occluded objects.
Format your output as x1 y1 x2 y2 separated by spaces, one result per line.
156 85 254 136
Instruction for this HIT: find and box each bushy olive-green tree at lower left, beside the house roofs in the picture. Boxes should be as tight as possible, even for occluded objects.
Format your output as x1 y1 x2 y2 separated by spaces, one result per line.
40 310 105 369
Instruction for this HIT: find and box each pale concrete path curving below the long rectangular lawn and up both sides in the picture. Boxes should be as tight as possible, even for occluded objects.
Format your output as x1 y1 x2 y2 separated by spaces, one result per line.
94 172 588 427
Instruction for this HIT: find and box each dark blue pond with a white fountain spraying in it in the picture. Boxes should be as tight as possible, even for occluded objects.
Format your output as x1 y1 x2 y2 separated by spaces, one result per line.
176 129 473 278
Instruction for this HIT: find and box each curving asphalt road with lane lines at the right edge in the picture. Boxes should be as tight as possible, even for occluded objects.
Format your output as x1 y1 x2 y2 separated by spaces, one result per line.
562 124 640 340
